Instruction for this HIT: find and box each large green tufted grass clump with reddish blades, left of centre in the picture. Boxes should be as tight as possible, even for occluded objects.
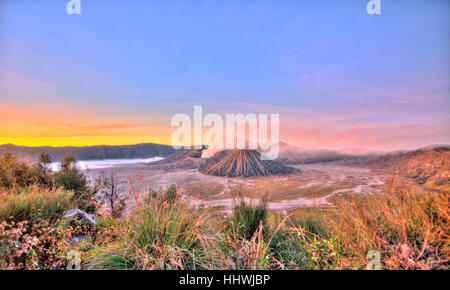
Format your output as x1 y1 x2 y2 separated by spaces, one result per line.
88 188 211 270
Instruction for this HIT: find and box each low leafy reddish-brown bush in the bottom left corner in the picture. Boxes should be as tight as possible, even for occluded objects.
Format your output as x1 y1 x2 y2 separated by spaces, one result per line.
0 220 111 270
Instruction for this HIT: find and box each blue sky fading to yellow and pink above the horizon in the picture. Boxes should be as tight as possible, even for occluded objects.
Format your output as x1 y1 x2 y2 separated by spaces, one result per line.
0 0 450 150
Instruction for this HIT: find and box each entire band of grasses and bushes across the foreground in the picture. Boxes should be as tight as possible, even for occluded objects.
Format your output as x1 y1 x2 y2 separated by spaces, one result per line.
0 152 450 269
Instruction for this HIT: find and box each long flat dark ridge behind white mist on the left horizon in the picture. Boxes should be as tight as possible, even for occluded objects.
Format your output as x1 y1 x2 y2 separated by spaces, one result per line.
0 143 175 162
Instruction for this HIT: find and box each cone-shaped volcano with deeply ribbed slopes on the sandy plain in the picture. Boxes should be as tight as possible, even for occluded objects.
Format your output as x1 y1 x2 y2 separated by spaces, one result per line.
200 150 299 177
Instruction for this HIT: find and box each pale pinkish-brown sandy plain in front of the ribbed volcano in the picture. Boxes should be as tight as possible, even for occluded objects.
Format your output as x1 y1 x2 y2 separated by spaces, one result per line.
87 162 387 213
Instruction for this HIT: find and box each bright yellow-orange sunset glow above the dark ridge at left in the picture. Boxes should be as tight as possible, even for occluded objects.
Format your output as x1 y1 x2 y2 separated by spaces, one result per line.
0 101 175 147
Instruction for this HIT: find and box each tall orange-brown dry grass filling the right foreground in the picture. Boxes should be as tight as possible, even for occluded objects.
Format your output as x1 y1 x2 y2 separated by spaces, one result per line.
330 180 450 269
